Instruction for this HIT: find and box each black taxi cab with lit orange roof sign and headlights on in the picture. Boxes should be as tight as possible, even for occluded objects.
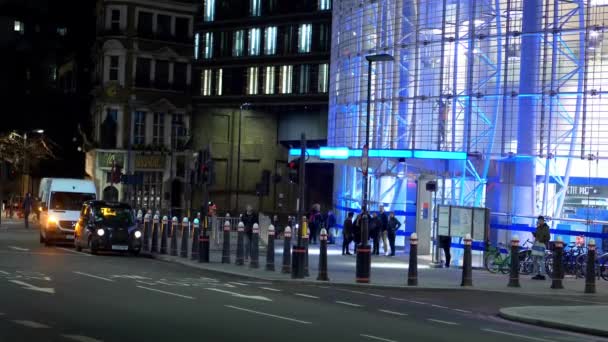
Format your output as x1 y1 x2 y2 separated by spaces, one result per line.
74 200 143 255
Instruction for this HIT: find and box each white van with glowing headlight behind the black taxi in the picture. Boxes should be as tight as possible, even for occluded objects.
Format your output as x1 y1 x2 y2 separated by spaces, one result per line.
38 178 96 246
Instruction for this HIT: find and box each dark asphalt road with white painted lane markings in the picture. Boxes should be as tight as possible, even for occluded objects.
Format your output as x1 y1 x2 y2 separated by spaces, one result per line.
0 222 605 342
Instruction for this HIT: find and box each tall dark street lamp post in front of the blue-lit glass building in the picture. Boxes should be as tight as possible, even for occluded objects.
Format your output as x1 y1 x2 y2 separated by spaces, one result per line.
356 53 394 283
